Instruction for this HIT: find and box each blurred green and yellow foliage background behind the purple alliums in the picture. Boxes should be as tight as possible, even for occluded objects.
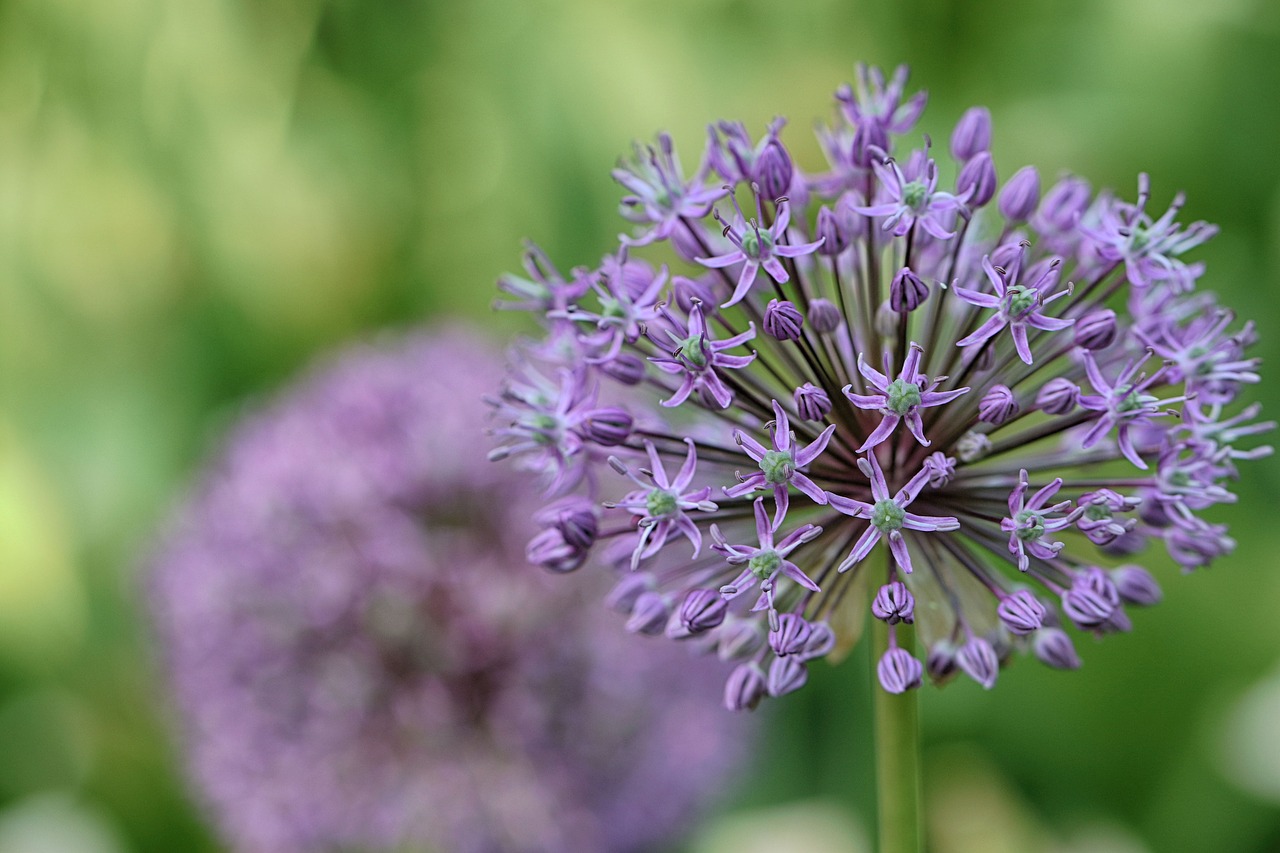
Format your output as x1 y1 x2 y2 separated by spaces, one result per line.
0 0 1280 853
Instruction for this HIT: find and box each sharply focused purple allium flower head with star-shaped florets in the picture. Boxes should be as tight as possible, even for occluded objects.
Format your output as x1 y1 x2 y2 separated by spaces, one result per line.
493 68 1274 708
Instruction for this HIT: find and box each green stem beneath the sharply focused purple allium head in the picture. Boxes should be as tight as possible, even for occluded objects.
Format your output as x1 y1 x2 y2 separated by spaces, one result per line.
872 619 924 853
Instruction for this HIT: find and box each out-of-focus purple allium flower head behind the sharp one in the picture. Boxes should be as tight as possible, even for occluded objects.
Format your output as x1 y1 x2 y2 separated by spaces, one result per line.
150 326 750 853
